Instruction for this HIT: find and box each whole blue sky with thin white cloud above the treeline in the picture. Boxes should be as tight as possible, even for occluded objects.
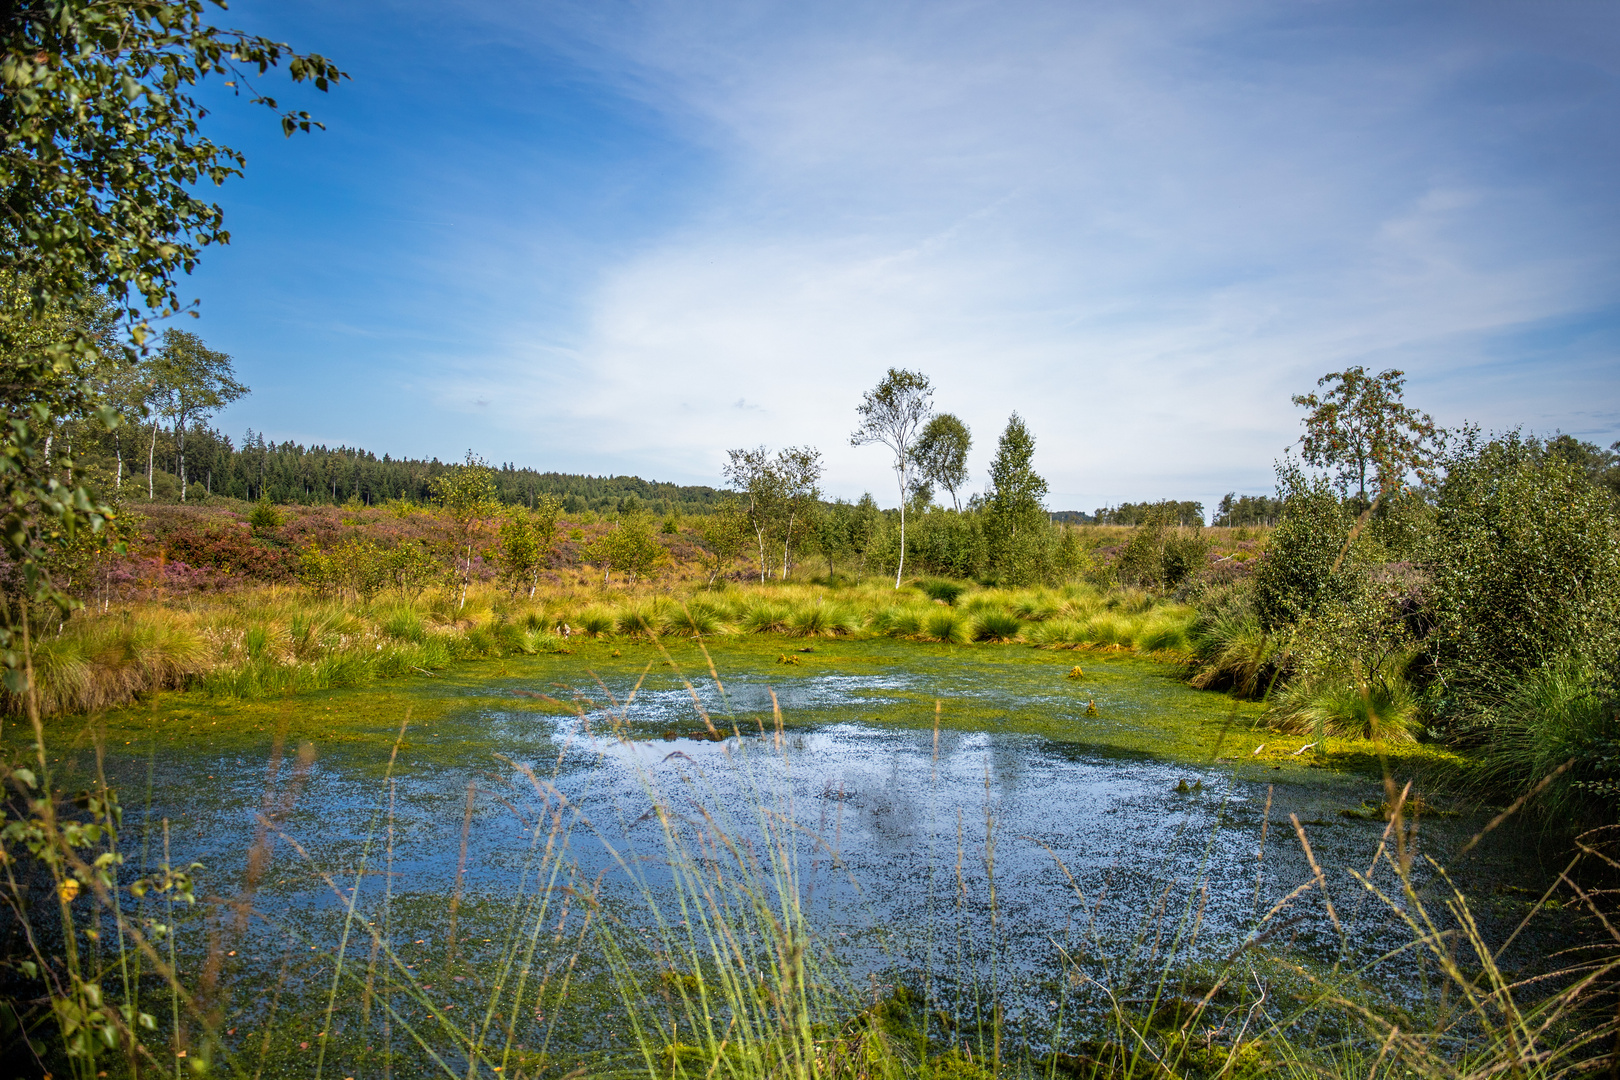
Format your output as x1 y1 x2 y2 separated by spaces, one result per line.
188 0 1620 510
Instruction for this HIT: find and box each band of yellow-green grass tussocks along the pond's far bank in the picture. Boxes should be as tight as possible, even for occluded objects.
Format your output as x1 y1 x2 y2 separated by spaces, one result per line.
5 580 1194 716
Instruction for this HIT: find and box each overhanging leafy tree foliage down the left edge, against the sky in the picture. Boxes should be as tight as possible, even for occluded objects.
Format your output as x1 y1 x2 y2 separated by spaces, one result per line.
0 0 342 761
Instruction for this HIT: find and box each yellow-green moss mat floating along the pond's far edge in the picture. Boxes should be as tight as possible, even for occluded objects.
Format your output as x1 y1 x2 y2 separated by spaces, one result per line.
22 637 1466 776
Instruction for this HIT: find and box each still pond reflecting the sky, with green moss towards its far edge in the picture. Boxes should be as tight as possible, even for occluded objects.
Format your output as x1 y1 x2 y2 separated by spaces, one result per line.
19 641 1545 1075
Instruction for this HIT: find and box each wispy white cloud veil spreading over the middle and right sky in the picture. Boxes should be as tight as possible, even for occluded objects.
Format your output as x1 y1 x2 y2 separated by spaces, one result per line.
411 2 1617 507
